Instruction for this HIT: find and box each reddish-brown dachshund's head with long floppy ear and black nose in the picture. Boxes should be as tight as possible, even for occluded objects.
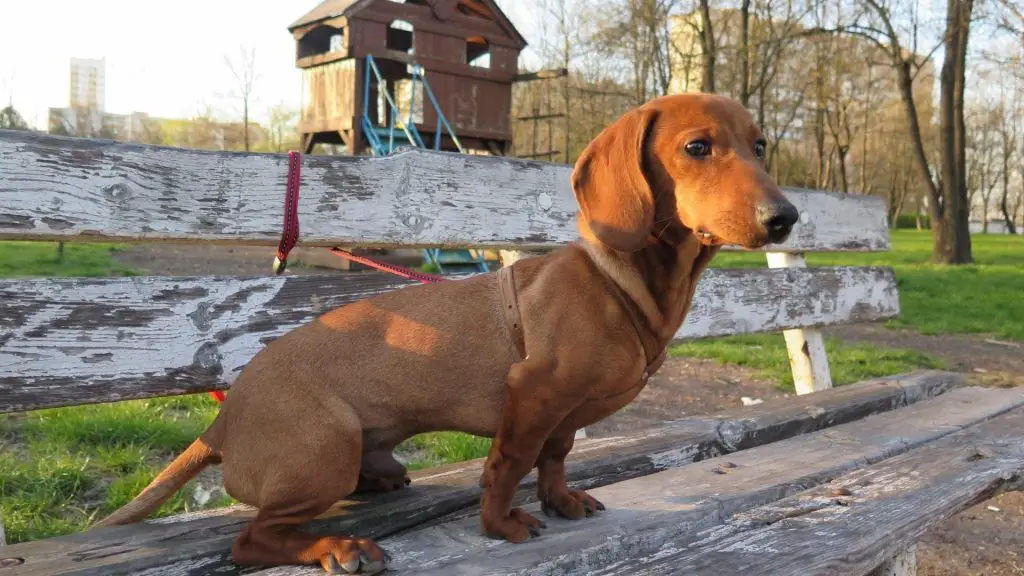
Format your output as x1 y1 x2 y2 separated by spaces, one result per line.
572 94 799 252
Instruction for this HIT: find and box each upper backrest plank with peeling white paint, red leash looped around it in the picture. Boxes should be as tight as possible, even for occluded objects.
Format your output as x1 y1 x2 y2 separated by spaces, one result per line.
0 130 889 251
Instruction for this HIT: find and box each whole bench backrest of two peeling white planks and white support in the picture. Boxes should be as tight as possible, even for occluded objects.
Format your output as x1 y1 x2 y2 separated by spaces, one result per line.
0 130 899 413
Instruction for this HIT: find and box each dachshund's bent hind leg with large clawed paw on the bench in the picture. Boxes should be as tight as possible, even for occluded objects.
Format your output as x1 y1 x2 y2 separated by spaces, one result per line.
225 403 385 574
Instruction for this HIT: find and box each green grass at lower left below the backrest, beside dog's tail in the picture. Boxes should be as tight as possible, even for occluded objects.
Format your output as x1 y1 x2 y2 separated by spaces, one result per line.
0 396 224 542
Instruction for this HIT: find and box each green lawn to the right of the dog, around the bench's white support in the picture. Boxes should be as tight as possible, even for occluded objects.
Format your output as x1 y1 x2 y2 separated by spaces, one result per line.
671 230 1024 389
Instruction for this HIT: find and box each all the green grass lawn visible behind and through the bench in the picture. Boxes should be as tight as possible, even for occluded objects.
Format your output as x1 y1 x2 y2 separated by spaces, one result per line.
0 231 1024 542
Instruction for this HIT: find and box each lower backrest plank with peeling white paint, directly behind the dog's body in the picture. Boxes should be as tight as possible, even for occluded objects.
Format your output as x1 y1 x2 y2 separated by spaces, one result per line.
0 268 899 413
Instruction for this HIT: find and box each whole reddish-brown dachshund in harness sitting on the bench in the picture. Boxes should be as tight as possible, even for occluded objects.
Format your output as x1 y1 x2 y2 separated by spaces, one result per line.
97 94 798 573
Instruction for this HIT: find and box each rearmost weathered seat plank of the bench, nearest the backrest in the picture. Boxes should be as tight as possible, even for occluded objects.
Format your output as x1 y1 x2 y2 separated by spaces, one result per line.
5 371 963 576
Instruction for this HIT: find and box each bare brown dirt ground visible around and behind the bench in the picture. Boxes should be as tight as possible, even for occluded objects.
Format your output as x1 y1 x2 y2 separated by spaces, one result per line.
117 244 1024 576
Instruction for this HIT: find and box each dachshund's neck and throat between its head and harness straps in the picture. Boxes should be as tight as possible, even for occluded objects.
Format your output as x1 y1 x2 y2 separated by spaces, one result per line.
580 231 718 346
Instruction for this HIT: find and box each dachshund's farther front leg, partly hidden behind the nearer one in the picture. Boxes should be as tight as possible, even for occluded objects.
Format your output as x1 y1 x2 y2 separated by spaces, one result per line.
537 436 604 520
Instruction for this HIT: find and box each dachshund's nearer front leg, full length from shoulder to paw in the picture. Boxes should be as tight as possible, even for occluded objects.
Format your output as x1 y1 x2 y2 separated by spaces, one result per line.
480 359 574 542
